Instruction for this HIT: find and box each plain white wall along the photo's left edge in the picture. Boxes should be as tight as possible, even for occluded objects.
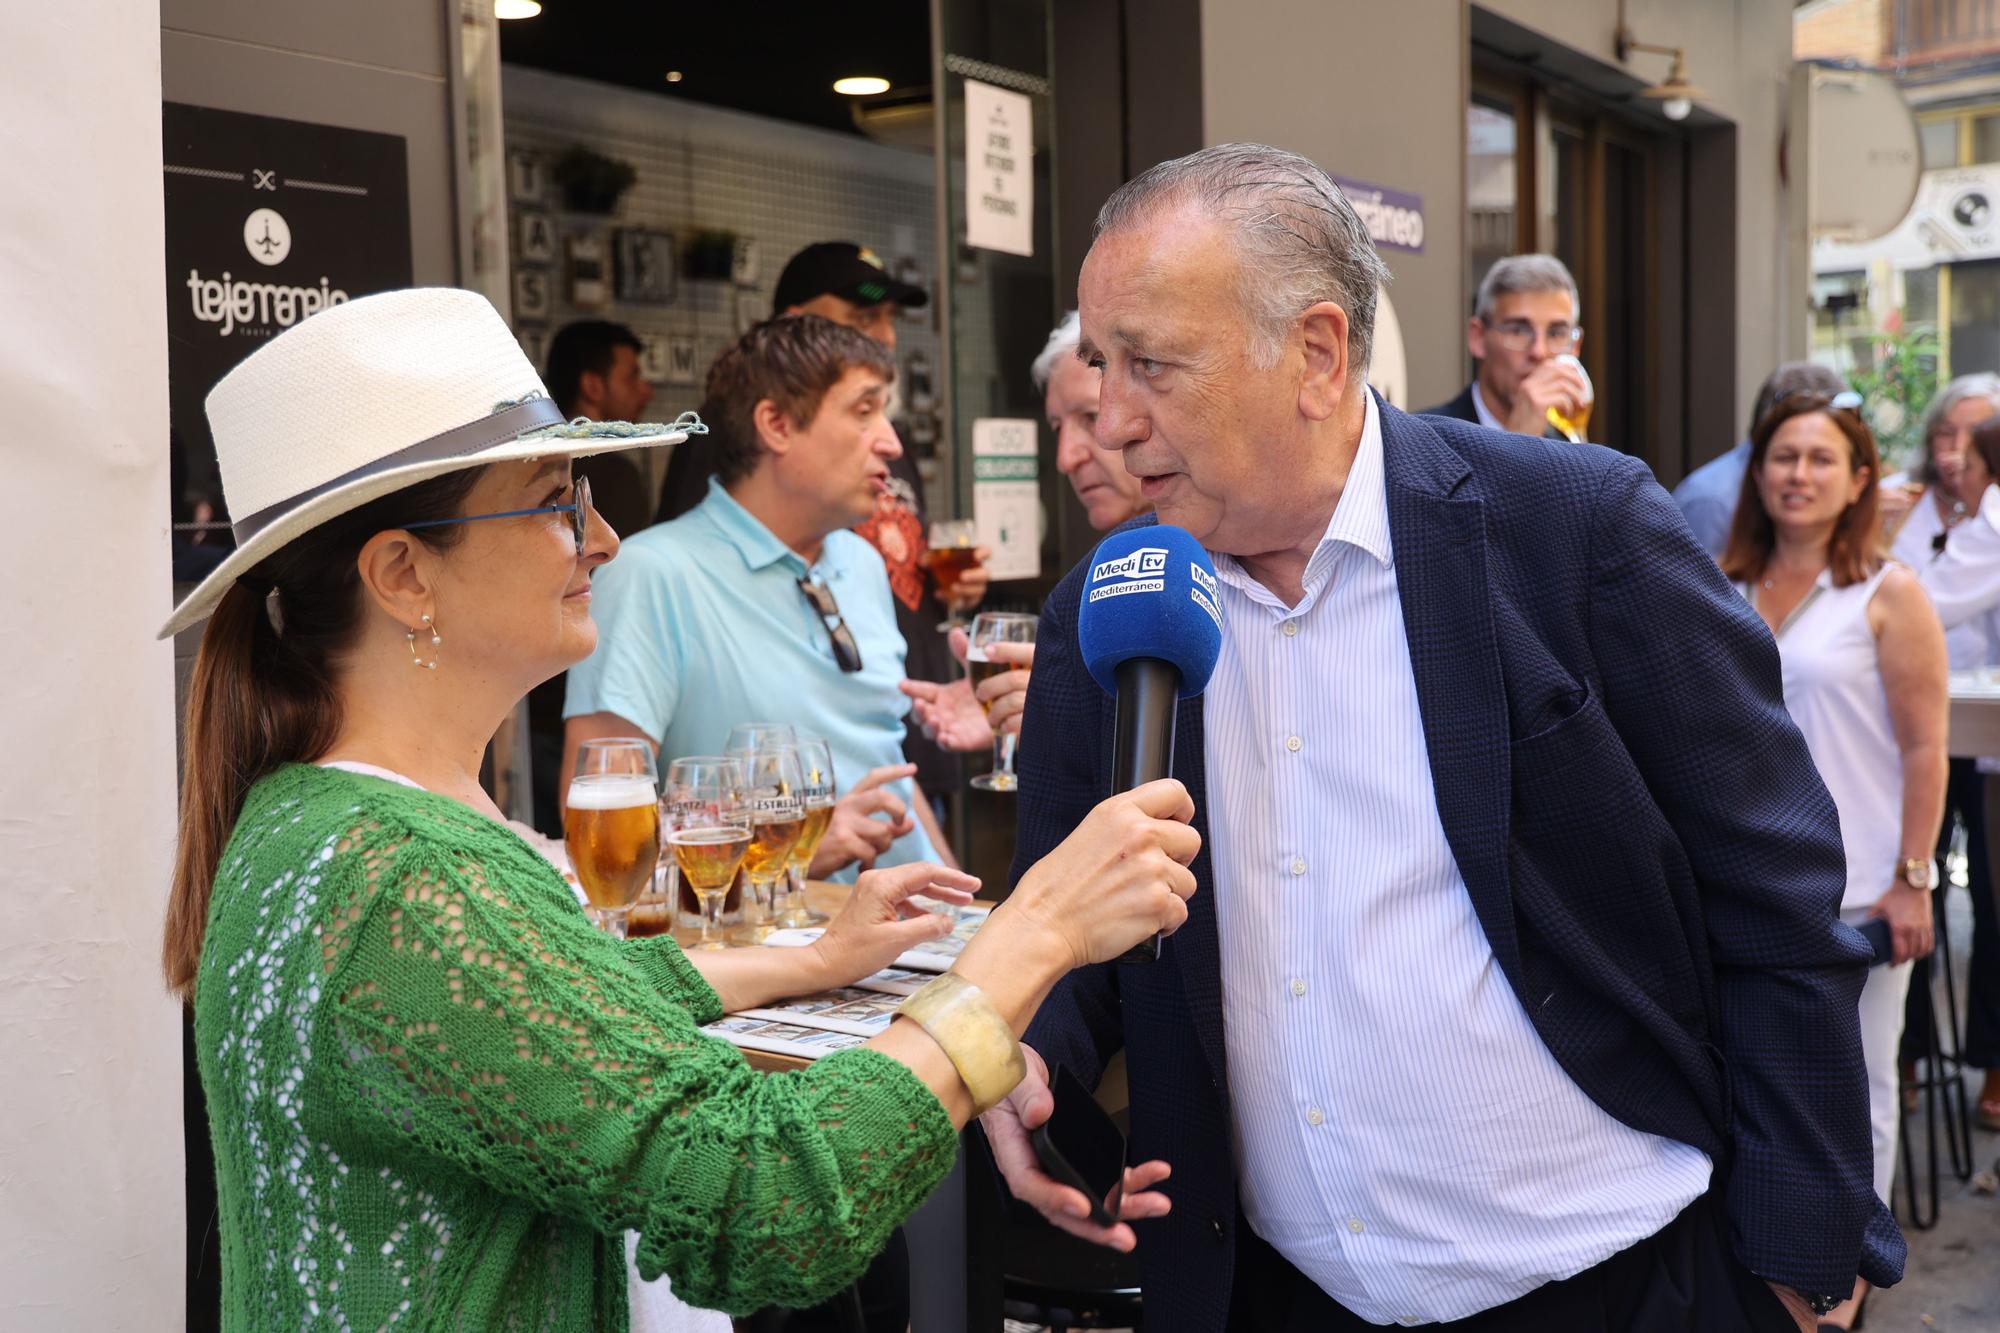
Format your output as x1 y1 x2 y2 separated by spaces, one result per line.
0 0 182 1333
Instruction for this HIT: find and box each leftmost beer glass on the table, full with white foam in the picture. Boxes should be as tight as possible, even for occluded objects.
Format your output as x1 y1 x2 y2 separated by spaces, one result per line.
562 737 660 939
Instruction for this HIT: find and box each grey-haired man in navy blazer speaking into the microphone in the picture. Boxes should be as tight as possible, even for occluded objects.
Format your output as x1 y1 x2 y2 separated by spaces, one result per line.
986 144 1904 1333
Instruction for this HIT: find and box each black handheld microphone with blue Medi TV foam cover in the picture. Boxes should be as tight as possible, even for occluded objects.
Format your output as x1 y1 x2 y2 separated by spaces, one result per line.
1076 524 1222 963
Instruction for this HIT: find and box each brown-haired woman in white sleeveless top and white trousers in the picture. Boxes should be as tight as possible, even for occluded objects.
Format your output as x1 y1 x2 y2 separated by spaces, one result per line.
1722 394 1948 1327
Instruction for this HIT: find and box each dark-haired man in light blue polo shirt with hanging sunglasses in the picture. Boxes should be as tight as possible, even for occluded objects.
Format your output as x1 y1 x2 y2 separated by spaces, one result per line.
562 314 948 875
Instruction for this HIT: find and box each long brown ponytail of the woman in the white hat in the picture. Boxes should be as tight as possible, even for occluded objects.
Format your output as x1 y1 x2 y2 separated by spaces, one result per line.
160 468 482 1001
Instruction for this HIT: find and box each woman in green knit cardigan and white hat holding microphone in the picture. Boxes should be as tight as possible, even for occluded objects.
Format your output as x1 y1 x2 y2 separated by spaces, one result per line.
164 288 1196 1331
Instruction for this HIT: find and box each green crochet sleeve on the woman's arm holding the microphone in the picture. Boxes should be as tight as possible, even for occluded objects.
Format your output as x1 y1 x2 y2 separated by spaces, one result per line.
304 784 954 1313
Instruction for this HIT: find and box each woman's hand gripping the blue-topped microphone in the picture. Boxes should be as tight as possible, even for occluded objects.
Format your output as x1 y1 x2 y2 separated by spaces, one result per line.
1008 779 1202 967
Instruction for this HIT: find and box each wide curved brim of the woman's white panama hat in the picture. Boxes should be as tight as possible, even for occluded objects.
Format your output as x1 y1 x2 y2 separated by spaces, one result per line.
158 422 688 638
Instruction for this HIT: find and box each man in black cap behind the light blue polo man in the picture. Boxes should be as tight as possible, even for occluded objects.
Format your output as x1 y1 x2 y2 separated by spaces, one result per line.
654 240 986 823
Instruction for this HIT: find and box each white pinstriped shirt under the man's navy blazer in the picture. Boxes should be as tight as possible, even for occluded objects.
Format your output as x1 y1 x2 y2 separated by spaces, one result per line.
1202 396 1710 1323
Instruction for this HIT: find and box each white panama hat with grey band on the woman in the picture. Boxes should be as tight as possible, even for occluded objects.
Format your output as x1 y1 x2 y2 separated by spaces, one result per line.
160 286 708 638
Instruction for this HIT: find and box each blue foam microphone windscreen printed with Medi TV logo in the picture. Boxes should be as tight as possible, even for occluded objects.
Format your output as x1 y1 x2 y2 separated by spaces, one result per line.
1076 522 1222 699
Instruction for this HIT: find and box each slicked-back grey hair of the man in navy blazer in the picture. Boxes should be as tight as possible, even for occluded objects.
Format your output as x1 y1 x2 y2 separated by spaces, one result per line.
1096 144 1390 370
